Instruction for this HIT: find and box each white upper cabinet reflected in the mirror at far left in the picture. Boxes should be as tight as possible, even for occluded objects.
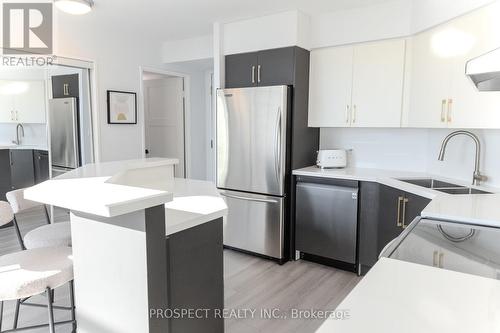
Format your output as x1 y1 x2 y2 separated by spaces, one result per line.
14 81 46 123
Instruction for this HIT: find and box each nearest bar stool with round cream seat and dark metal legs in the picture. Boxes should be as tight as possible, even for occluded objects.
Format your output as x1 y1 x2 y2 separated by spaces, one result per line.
0 245 76 333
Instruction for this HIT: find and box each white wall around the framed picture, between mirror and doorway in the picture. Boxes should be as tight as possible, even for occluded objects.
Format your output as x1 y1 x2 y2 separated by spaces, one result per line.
54 10 163 161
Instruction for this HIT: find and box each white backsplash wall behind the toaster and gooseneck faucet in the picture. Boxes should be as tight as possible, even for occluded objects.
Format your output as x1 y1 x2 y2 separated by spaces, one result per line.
320 128 500 187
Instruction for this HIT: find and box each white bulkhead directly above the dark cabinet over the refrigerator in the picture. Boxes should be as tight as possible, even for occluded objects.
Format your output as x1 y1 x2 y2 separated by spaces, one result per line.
223 10 310 54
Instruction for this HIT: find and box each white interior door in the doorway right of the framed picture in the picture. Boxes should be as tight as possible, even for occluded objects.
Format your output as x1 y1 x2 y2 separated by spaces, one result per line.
144 77 185 178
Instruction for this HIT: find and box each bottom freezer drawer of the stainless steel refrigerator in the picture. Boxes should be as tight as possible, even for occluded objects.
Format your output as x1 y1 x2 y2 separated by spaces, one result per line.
220 190 284 259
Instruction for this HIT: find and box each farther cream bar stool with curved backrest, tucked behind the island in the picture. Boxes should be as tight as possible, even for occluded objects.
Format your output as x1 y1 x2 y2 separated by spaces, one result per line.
6 189 71 250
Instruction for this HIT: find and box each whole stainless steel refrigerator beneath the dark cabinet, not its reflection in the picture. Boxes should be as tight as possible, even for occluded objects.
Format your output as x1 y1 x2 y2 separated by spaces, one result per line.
217 86 290 259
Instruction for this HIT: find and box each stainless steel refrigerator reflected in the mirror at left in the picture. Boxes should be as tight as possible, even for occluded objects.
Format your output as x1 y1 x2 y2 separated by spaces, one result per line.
49 97 80 177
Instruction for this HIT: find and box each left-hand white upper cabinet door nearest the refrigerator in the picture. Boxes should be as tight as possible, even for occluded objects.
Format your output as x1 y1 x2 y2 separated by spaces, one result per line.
308 46 353 127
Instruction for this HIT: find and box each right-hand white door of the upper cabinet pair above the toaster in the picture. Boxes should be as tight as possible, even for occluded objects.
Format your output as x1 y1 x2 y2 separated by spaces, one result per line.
351 40 405 127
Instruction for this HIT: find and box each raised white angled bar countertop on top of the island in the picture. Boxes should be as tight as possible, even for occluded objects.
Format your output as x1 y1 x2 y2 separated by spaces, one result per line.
24 159 178 217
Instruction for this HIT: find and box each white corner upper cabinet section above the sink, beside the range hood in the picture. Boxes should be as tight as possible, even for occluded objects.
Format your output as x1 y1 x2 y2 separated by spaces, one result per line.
404 5 500 128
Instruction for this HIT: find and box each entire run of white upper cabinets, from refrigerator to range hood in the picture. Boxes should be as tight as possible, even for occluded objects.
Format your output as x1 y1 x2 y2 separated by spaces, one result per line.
309 4 500 128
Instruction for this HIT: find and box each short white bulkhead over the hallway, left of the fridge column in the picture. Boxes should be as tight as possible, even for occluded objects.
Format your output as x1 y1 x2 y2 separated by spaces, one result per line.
162 35 213 63
